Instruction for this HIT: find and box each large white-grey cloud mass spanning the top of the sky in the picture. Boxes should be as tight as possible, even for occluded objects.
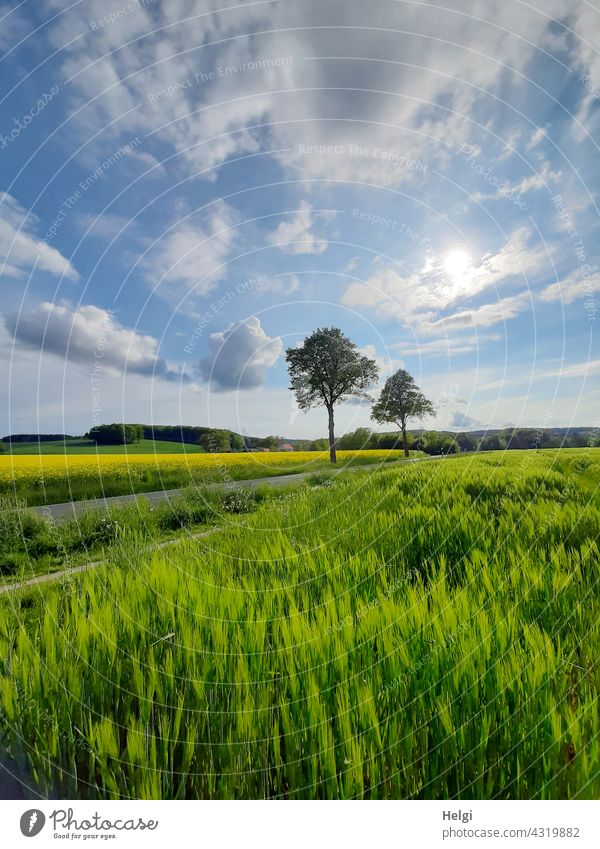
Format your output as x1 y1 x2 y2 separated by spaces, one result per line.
49 0 572 185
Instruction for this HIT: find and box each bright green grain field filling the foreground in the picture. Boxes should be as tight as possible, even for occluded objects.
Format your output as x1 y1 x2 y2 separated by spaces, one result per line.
0 449 600 799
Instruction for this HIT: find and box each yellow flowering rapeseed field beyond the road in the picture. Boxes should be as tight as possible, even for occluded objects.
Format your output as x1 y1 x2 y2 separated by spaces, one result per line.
0 450 419 506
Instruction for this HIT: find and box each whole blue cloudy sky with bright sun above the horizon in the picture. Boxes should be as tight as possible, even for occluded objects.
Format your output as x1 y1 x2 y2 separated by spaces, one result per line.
0 0 600 438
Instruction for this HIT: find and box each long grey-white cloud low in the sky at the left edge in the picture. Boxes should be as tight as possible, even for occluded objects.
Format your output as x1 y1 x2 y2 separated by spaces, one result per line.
4 302 187 381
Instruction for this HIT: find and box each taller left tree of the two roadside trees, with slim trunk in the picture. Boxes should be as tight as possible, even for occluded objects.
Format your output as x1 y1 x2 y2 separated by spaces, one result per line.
285 327 378 463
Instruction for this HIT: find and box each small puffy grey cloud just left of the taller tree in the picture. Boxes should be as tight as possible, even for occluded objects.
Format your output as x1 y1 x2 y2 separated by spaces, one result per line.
200 316 283 391
